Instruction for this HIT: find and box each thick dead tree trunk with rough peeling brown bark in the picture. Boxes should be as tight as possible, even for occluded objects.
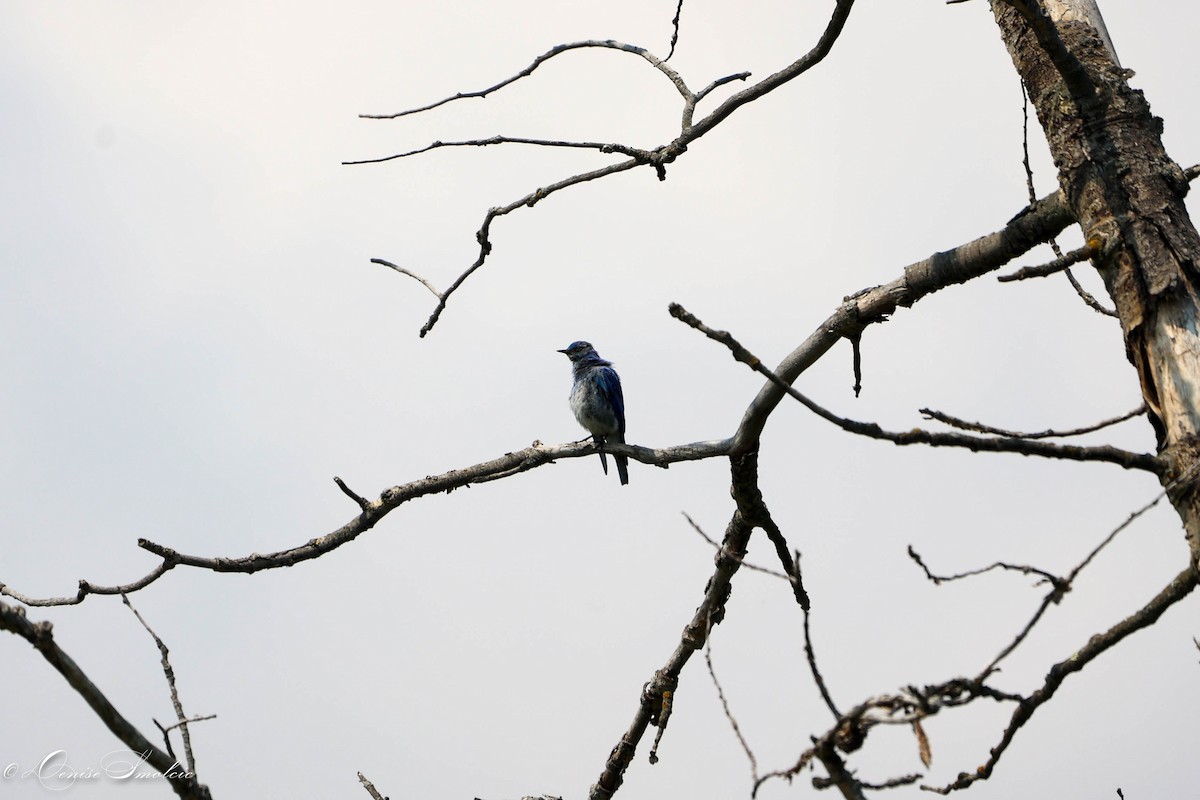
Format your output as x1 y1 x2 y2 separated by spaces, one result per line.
991 0 1200 570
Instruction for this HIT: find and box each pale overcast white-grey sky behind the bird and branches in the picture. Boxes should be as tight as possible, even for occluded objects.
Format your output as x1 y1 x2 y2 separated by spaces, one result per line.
0 0 1200 800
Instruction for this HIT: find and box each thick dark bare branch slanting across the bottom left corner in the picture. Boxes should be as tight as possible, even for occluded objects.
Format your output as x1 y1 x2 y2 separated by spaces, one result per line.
0 602 211 800
